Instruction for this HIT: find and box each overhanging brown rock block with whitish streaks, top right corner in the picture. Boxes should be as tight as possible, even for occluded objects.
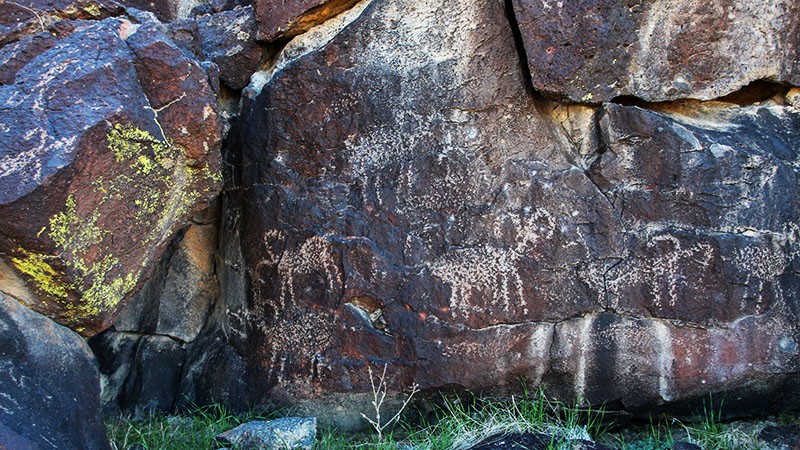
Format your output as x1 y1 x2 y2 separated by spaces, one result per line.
513 0 800 103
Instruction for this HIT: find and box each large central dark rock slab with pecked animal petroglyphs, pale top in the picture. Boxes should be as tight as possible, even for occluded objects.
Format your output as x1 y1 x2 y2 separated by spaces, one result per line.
227 1 588 397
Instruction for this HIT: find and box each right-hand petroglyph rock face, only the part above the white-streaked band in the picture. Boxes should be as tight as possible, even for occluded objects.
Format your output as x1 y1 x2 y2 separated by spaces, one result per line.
590 103 800 325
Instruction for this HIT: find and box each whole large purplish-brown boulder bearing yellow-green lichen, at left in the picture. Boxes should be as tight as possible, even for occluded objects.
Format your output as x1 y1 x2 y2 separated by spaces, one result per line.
0 14 221 334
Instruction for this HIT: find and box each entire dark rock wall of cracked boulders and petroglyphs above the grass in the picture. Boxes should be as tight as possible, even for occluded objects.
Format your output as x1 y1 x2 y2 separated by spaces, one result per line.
0 0 800 434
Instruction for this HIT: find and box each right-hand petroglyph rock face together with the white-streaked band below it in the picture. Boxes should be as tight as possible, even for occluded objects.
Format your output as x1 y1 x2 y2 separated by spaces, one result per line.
548 103 800 408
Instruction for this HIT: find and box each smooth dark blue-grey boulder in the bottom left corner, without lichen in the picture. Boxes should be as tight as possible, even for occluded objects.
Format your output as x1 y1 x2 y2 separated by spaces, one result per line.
0 293 110 450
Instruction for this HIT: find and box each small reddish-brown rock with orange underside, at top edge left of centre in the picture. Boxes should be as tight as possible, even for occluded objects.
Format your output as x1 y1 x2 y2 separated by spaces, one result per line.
254 0 358 41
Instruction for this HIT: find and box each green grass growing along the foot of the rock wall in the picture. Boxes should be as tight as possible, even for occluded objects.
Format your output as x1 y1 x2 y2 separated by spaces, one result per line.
108 391 797 450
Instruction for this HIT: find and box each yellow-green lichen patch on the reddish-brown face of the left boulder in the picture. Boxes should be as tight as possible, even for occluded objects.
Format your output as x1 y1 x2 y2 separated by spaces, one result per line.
12 120 221 326
